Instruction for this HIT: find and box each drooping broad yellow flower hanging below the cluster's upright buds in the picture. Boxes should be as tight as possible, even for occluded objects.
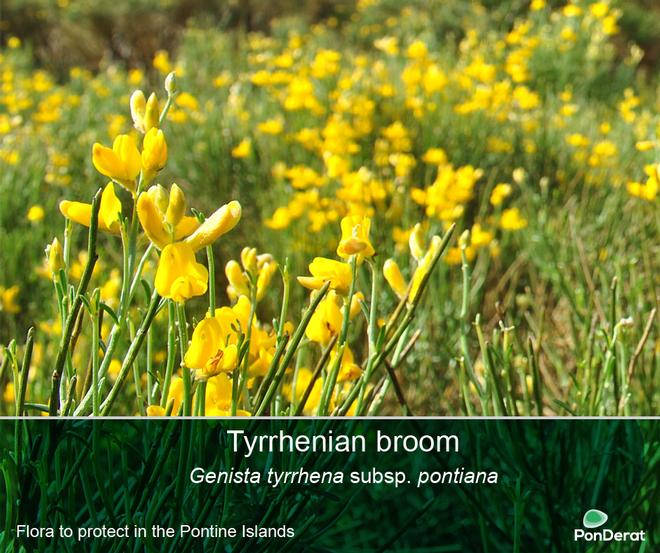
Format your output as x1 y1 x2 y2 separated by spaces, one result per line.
155 242 209 302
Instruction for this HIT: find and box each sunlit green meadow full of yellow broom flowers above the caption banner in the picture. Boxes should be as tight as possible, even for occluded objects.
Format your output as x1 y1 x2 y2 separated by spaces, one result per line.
0 0 660 416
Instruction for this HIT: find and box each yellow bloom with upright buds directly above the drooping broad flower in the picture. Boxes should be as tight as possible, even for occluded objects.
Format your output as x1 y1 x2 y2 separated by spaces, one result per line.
137 184 199 249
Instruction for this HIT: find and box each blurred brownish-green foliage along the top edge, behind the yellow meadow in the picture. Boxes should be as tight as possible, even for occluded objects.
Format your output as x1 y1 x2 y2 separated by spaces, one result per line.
0 0 660 77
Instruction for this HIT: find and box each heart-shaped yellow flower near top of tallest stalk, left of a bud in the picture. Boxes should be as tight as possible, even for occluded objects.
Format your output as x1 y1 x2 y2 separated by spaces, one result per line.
92 134 142 192
